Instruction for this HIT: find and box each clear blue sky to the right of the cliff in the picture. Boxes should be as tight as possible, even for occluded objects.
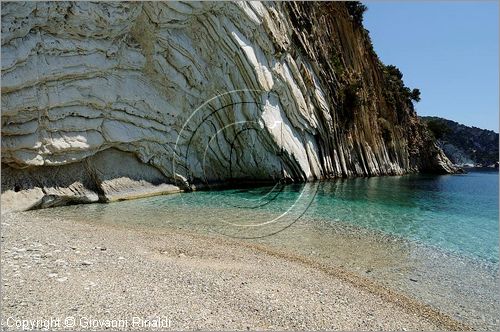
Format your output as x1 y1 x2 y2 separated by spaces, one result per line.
363 1 499 132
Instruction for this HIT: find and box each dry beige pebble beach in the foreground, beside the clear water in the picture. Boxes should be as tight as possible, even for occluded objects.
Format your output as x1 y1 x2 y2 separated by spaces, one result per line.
1 213 467 330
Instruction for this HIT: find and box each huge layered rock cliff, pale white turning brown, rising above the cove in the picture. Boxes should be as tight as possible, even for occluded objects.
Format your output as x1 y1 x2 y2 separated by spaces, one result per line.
1 2 453 210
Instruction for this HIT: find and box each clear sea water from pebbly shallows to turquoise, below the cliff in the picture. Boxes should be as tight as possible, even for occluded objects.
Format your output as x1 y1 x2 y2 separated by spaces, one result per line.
32 170 500 329
